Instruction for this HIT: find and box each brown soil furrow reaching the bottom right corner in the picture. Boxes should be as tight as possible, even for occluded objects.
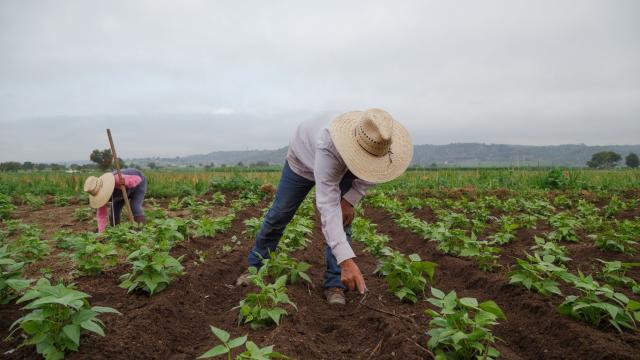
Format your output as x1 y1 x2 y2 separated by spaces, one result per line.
365 208 640 360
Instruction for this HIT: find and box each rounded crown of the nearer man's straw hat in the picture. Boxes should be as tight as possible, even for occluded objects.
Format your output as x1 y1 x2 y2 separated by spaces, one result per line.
355 109 394 156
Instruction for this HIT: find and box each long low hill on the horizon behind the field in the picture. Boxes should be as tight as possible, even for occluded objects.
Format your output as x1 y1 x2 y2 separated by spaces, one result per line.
129 143 640 167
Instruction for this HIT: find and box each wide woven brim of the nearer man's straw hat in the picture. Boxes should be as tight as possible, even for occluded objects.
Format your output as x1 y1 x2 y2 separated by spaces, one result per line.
329 111 413 183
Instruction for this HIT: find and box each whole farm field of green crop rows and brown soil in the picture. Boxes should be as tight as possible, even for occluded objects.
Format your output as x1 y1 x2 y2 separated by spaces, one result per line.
0 170 640 359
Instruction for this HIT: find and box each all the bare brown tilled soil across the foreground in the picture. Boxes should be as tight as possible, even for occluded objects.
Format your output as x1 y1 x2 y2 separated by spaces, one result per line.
0 197 640 359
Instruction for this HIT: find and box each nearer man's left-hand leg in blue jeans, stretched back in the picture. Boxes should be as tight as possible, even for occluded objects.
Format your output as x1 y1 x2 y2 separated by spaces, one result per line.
249 163 314 267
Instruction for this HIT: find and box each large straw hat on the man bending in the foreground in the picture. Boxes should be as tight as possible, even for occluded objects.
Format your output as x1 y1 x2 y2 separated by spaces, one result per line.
329 109 413 183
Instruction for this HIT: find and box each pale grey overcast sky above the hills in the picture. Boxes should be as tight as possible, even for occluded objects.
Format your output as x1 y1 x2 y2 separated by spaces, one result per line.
0 0 640 161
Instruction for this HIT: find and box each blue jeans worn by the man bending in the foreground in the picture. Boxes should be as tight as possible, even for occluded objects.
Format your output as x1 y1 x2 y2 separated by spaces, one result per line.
249 162 356 289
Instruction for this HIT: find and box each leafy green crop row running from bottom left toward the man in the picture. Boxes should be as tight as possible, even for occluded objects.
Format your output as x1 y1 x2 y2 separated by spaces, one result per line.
0 186 261 359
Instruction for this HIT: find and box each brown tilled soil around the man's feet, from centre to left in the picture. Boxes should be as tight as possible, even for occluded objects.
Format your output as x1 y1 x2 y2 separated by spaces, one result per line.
0 200 428 359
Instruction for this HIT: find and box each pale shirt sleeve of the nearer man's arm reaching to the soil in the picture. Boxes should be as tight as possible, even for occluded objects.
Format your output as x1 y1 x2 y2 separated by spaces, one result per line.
313 132 356 264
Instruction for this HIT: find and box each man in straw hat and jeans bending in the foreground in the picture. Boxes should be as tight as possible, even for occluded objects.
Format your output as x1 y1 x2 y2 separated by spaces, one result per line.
236 109 413 305
